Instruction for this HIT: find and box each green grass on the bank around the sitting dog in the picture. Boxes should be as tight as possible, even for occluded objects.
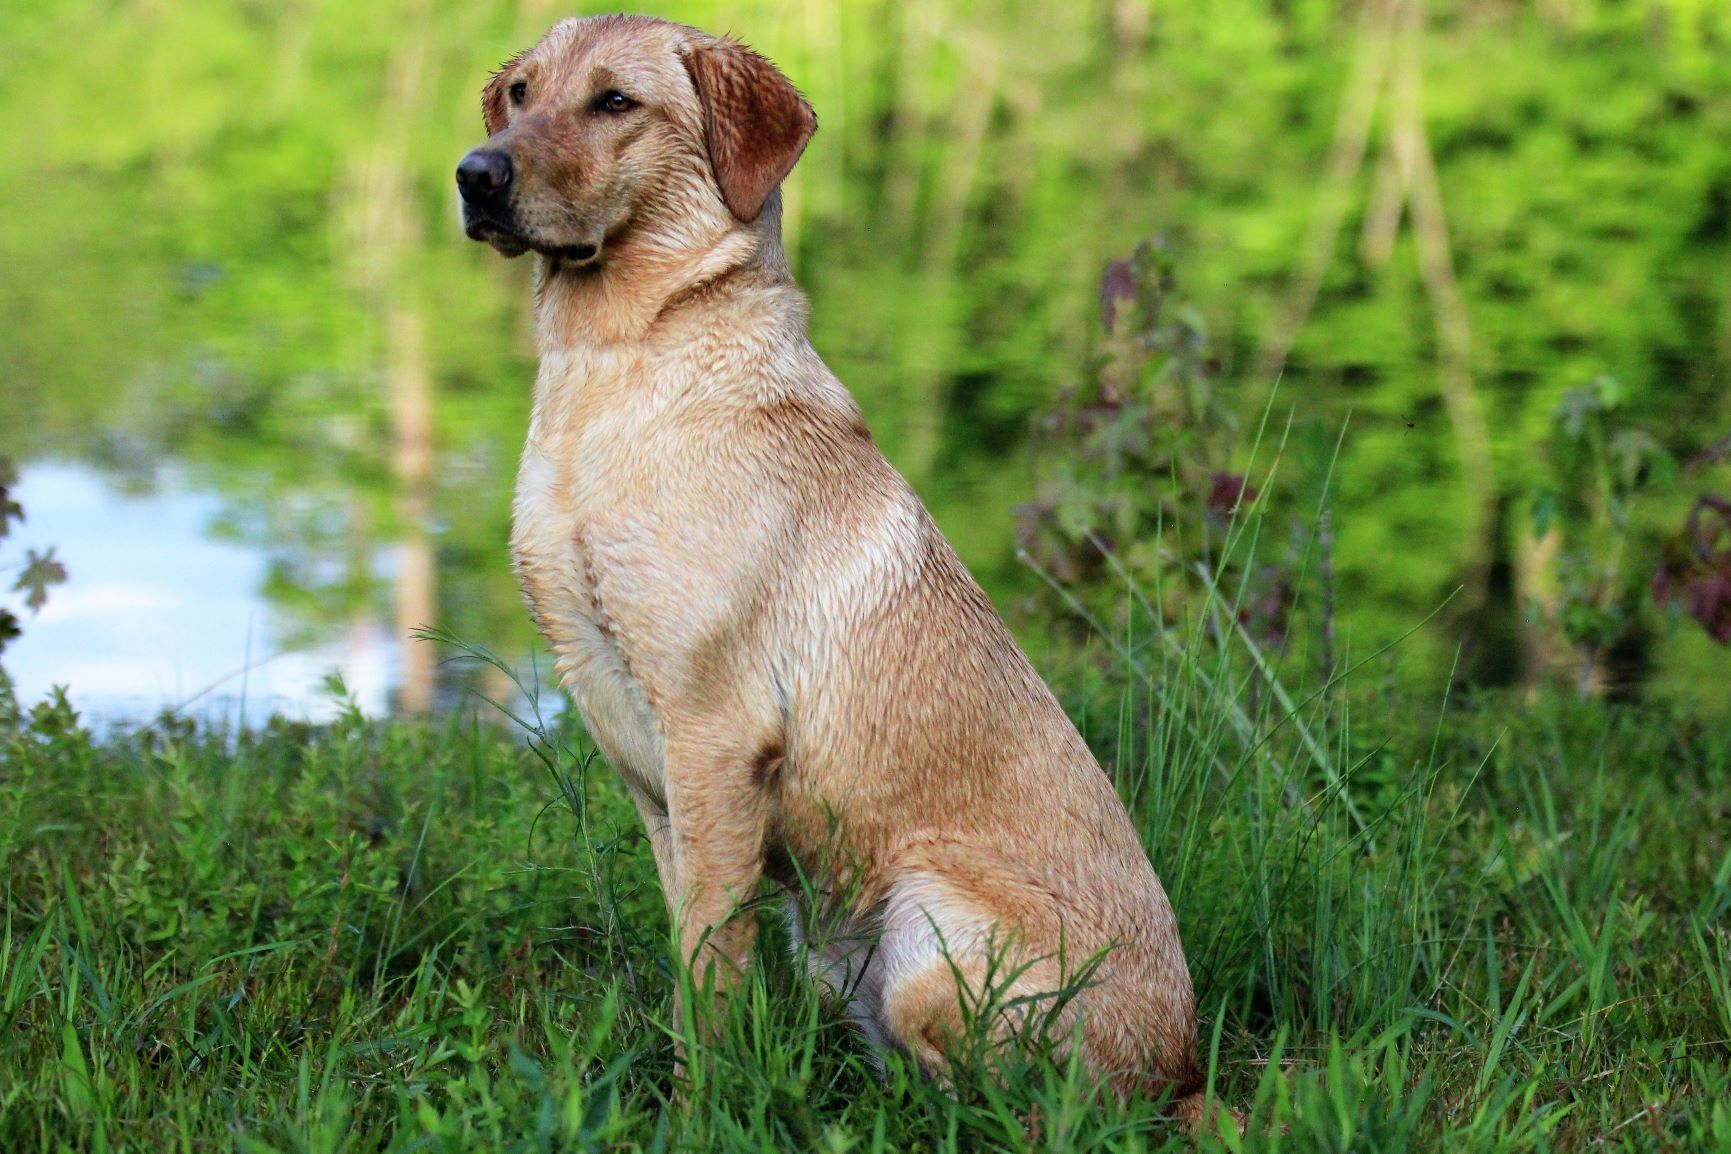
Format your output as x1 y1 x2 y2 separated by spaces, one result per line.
0 630 1731 1154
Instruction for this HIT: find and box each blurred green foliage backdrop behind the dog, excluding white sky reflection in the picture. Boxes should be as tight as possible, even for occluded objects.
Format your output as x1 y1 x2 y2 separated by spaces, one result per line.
0 0 1731 709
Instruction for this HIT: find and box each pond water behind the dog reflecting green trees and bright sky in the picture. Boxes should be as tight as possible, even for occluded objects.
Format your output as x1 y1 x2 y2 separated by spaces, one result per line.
0 0 1731 720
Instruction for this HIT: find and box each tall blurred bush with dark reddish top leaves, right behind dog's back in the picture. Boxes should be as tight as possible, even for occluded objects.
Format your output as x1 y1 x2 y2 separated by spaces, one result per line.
1016 242 1293 653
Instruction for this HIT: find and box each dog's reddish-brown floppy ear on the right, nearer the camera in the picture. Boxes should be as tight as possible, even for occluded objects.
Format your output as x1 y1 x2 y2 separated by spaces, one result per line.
685 40 817 223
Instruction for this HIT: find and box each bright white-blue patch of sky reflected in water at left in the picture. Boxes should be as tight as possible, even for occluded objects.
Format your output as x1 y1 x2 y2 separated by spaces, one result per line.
7 462 405 723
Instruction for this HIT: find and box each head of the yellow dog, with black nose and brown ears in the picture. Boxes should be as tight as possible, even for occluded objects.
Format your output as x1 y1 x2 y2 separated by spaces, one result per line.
457 16 817 266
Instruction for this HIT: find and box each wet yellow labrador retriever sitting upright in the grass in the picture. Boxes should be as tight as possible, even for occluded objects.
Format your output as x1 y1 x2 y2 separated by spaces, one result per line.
457 16 1201 1119
